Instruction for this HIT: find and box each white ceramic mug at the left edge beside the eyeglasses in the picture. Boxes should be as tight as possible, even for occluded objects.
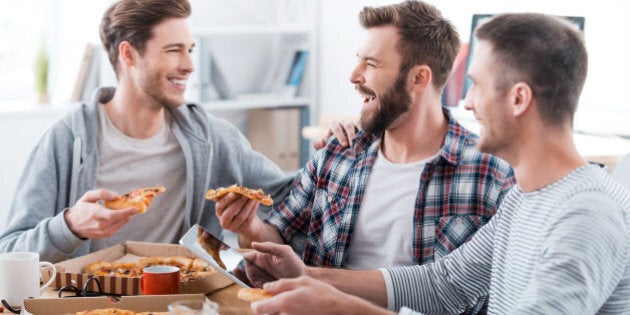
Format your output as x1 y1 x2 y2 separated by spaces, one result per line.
0 252 57 306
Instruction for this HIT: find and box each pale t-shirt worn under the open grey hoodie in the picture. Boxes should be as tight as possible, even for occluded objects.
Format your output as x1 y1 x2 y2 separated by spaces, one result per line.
91 104 186 251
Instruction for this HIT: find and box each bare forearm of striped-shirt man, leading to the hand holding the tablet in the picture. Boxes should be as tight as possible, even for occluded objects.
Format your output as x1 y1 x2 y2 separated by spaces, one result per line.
306 267 387 307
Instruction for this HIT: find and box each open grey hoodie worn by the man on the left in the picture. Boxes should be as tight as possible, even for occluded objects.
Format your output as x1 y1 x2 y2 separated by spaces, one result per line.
0 88 294 262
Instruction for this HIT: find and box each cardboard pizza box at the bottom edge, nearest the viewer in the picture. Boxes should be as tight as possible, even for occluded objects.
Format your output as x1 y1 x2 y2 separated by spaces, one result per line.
22 294 205 315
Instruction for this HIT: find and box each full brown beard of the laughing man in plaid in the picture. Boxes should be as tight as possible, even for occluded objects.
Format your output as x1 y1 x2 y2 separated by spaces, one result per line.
357 74 411 135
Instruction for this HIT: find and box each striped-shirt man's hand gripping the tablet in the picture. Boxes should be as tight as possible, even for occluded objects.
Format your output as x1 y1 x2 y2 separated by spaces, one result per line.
243 242 306 287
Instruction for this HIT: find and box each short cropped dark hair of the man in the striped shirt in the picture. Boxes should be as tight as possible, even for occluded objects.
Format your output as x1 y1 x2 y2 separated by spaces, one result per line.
476 13 588 124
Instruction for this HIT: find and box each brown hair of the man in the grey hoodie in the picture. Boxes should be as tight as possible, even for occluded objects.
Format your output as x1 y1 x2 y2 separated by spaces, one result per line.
100 0 191 76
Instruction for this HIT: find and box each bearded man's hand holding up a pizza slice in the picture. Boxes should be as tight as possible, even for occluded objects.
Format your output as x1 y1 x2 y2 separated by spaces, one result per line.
215 193 264 239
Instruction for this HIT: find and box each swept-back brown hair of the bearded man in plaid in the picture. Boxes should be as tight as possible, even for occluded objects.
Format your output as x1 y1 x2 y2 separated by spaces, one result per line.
359 1 461 89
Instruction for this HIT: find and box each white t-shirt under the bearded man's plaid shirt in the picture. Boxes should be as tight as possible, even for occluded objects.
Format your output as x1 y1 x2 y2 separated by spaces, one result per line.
344 150 429 270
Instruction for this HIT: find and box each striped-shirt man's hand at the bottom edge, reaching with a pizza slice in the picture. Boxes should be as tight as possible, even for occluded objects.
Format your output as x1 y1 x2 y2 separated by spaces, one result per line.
251 276 391 315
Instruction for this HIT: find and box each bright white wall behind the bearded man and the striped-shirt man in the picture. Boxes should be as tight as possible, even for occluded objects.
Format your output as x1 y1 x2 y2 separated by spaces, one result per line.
319 0 630 136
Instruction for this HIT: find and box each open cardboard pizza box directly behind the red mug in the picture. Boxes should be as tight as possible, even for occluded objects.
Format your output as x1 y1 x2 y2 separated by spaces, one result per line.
43 242 233 295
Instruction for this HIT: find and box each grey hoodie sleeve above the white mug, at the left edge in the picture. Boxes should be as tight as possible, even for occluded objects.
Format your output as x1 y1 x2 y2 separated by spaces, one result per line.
0 122 83 263
